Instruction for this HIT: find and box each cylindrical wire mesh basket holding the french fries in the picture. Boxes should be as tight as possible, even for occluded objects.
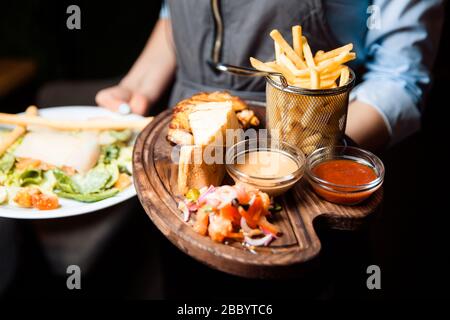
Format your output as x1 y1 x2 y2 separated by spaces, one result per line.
266 70 355 155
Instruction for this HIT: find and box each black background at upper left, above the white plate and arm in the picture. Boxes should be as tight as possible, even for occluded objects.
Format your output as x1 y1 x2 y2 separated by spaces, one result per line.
0 0 161 112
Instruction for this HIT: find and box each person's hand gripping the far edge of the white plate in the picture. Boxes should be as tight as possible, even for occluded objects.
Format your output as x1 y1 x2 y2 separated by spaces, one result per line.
95 84 149 115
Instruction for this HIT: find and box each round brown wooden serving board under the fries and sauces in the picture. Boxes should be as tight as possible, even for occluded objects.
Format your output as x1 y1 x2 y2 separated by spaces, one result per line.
133 106 382 278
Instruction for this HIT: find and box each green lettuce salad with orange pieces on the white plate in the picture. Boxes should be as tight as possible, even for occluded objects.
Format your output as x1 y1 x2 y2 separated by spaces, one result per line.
0 130 134 209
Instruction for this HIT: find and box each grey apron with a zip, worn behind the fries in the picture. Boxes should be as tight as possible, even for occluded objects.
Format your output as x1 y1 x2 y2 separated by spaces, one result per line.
168 0 340 106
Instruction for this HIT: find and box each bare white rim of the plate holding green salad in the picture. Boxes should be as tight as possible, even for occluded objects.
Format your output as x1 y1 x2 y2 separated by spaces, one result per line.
0 106 142 219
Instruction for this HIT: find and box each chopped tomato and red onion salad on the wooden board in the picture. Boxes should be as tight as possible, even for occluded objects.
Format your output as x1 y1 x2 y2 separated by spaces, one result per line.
178 184 281 247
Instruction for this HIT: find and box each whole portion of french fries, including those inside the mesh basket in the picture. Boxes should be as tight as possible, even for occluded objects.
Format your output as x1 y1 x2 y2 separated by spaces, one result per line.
256 25 356 154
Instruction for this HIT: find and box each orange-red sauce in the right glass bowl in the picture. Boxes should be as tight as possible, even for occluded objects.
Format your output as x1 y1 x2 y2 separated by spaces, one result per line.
312 160 377 205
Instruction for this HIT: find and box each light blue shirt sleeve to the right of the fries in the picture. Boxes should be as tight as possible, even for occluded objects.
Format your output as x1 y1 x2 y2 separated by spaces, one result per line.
351 0 443 143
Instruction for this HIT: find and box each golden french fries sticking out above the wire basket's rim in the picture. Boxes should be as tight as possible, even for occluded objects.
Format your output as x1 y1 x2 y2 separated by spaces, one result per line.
250 25 356 90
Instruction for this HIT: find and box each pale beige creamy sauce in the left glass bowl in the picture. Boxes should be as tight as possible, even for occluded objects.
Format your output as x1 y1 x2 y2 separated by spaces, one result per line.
234 150 299 178
